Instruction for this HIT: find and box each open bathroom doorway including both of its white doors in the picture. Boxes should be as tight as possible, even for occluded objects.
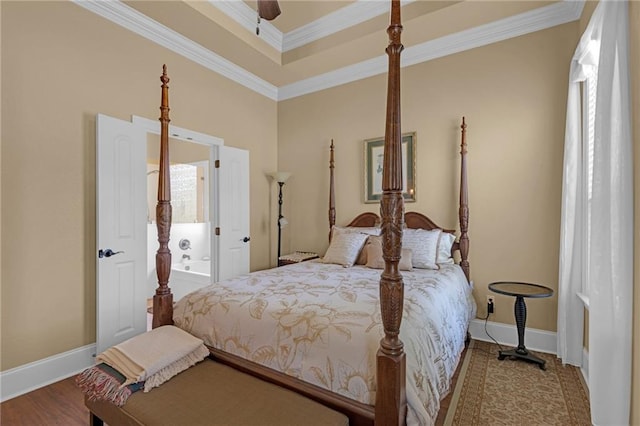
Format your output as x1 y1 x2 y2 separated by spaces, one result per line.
96 114 250 353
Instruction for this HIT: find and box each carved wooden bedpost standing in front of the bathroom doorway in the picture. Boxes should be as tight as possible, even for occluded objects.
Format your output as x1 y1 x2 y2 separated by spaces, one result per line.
152 65 173 328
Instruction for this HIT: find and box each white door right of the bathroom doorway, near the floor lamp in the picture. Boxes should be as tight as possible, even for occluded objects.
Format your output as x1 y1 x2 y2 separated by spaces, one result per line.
217 146 251 280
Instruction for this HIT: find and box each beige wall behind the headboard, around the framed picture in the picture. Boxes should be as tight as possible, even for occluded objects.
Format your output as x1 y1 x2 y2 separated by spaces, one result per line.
278 23 578 331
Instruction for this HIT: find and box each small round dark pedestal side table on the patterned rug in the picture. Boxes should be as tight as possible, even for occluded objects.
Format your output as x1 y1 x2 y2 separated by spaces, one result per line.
489 281 553 370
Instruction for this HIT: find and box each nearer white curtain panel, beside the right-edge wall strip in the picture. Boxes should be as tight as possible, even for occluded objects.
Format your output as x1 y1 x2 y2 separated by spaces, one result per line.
589 1 633 425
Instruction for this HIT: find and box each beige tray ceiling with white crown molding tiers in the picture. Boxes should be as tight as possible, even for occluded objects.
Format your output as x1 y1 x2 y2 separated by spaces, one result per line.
82 0 583 99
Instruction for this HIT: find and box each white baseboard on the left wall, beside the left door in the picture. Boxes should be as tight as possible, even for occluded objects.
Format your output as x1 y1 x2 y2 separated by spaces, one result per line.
0 343 96 402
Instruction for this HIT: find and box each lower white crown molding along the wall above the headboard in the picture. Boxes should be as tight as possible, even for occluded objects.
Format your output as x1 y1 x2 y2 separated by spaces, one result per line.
278 0 584 101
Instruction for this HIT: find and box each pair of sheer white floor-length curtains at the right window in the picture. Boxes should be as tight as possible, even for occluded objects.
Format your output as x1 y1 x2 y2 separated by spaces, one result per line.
558 1 633 425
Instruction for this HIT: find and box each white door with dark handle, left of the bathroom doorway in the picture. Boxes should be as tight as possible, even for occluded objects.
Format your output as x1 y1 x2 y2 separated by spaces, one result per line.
96 114 147 353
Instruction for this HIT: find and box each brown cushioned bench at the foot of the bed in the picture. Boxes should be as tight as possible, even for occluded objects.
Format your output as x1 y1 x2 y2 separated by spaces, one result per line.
85 359 349 426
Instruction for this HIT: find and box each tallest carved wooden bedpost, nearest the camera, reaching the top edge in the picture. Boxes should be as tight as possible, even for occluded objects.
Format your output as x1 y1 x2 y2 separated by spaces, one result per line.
375 0 407 426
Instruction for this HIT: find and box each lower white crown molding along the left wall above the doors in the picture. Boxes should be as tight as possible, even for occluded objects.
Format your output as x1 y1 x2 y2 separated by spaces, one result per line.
72 0 278 100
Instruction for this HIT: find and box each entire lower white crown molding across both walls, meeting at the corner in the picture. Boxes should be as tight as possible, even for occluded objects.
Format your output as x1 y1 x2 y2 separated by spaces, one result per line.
72 0 584 101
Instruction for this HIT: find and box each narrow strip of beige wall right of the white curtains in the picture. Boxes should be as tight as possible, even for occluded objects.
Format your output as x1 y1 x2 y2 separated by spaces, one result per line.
629 1 640 425
